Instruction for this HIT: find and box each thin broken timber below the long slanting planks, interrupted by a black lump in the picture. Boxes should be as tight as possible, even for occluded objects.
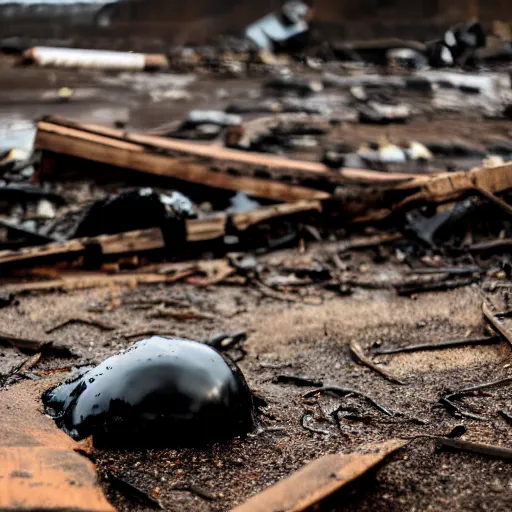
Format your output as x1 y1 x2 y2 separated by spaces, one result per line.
0 201 322 265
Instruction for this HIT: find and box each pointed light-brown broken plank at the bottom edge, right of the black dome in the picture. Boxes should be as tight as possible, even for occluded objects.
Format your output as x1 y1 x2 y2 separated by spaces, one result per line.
232 439 408 512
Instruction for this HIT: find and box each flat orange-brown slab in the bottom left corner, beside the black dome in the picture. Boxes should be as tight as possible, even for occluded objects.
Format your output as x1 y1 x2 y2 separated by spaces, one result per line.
0 381 114 512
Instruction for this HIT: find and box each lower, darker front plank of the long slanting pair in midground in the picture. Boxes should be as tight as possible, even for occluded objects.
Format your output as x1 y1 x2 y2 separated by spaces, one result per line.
35 122 329 202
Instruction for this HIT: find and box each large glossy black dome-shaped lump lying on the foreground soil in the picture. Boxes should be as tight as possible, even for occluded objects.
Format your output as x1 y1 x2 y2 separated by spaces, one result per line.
43 336 253 447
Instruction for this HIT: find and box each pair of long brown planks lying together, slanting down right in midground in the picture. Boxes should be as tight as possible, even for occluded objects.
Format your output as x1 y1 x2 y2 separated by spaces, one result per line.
35 118 431 198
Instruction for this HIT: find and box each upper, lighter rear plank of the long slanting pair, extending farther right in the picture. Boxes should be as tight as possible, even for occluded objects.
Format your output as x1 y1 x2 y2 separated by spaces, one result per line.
36 117 432 188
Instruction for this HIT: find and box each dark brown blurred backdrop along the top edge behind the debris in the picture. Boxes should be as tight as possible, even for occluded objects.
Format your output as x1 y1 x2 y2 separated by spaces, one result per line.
0 0 512 46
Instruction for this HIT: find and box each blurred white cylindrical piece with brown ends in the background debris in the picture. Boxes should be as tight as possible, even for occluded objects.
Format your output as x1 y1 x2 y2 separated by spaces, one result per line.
23 46 169 71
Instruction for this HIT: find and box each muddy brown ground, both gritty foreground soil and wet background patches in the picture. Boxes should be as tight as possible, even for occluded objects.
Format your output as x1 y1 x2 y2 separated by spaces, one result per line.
0 54 512 512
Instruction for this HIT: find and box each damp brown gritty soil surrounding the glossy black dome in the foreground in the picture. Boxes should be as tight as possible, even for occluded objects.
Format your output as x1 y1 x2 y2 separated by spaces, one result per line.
0 278 512 511
